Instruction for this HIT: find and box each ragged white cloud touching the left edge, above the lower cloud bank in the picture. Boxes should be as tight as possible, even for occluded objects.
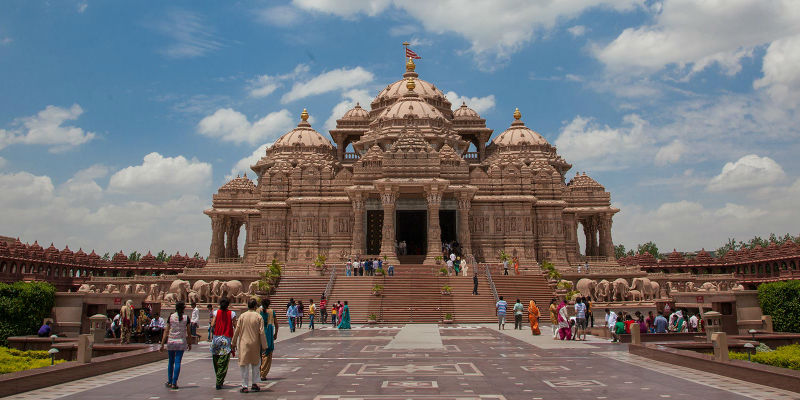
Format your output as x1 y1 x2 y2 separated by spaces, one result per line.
0 104 95 153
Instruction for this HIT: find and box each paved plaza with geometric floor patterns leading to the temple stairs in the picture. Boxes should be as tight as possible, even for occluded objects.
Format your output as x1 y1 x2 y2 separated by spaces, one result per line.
7 324 800 400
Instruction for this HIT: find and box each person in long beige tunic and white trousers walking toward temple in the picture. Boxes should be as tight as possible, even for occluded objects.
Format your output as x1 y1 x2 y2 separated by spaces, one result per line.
232 299 268 393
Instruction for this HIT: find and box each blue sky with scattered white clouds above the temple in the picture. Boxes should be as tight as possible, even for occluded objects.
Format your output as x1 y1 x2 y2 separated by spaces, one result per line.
0 0 800 254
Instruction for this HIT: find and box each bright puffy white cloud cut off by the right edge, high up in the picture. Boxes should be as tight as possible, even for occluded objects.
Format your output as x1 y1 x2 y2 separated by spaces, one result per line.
753 35 800 108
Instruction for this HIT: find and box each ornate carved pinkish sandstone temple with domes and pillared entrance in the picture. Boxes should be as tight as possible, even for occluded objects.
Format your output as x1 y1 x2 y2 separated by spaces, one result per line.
205 59 619 266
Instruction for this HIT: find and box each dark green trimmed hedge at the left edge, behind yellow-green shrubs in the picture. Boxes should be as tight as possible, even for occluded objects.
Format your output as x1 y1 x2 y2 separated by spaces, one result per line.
0 282 56 346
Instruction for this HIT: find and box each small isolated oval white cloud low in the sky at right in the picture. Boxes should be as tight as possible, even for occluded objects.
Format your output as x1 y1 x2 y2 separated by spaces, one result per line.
708 154 786 192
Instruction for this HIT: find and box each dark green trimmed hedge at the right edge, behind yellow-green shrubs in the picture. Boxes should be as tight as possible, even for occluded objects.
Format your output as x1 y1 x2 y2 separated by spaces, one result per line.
758 280 800 333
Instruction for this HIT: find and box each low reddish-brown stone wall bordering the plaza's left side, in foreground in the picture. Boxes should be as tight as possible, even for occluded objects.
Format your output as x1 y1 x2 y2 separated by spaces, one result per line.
0 346 167 397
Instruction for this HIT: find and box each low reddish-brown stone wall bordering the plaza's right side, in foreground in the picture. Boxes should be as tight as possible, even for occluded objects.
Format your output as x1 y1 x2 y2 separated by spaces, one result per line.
628 343 800 393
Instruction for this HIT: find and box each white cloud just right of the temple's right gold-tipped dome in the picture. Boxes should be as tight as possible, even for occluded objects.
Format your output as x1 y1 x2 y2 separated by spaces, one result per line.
555 114 651 170
